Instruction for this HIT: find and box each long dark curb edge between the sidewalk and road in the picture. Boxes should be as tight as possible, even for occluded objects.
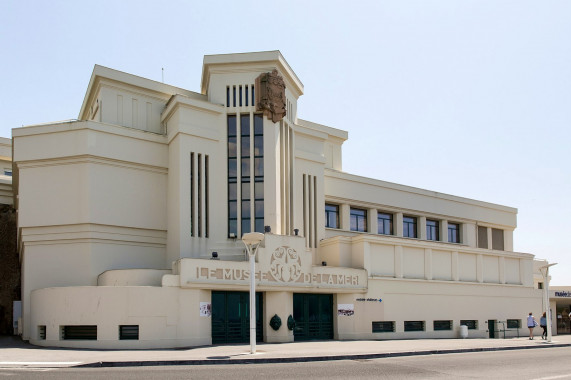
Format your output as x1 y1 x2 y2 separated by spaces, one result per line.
73 343 571 368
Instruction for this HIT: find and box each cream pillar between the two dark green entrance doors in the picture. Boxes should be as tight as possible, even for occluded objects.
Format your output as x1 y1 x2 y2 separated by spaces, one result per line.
264 292 293 343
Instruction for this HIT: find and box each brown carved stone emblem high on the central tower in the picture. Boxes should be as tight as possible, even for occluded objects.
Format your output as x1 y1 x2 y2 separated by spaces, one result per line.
256 69 286 123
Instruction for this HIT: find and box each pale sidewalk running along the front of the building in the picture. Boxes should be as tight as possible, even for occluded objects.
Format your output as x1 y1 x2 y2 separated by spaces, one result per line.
0 335 571 368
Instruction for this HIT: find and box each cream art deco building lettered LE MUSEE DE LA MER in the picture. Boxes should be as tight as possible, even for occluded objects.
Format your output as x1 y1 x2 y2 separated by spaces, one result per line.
13 51 552 348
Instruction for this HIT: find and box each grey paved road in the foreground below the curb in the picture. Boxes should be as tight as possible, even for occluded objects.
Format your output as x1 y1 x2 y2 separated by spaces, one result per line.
0 348 571 380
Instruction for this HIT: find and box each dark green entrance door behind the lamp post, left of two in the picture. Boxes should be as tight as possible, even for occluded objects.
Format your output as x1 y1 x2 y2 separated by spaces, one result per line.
212 291 262 344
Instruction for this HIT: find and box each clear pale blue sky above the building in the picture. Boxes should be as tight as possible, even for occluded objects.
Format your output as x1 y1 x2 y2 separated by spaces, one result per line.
0 0 571 285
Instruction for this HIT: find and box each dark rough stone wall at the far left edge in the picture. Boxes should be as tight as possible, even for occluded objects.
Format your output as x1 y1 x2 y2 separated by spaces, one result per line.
0 205 21 335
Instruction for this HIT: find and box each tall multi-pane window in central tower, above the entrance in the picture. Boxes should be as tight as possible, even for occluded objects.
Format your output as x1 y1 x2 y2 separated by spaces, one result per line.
227 113 264 237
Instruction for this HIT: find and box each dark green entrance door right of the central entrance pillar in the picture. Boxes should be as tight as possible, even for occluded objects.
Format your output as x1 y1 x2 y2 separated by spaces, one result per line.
293 293 333 341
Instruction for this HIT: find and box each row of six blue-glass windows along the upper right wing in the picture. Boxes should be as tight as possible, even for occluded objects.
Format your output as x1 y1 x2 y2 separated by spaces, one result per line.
325 204 460 243
